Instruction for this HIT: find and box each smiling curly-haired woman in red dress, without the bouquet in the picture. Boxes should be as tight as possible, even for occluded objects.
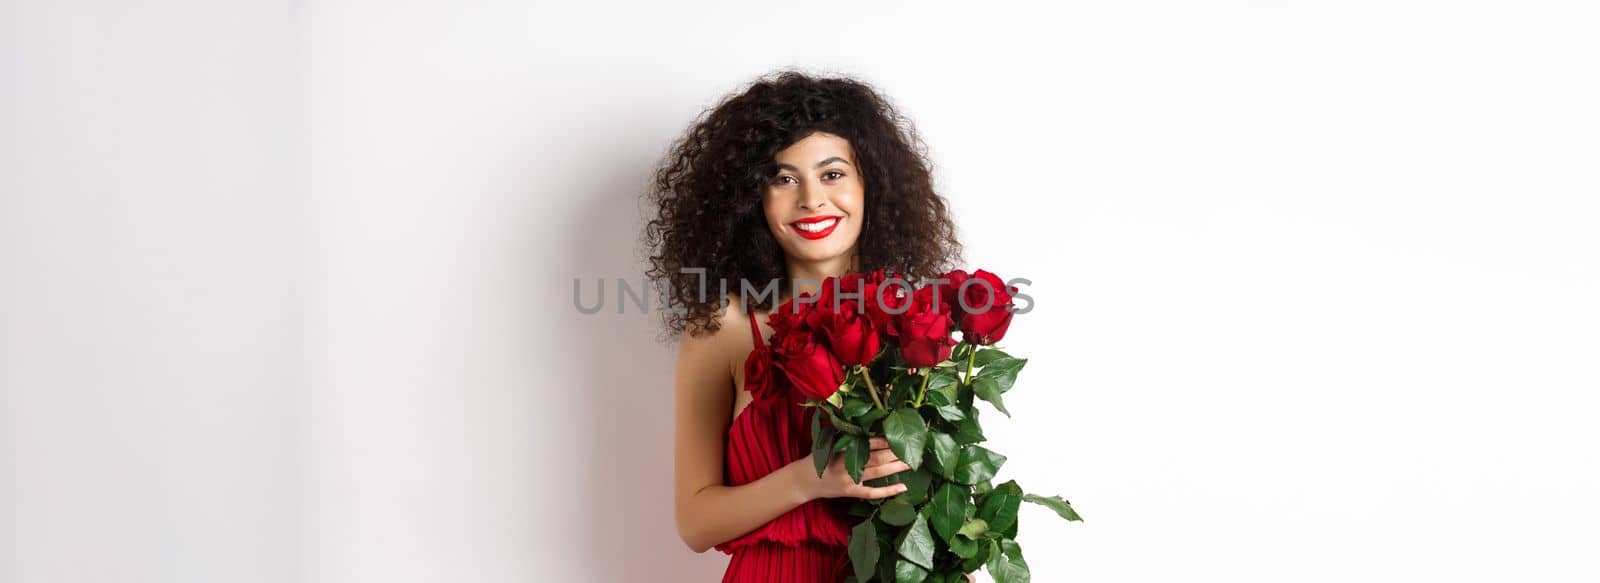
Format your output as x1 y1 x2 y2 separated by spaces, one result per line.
645 72 962 583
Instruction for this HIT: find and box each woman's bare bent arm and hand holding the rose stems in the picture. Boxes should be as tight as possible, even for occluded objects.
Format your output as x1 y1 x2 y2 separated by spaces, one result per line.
674 309 910 553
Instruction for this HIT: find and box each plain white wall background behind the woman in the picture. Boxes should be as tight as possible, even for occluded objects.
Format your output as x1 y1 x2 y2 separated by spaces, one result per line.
0 0 1600 583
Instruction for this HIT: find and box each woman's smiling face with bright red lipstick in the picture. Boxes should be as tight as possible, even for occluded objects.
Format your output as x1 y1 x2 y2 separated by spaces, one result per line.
762 131 864 263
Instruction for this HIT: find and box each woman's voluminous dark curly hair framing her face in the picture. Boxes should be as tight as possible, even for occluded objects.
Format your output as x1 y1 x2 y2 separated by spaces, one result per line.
643 70 962 335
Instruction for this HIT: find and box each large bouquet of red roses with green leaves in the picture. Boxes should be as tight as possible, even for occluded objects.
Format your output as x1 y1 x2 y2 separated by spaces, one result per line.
755 269 1082 583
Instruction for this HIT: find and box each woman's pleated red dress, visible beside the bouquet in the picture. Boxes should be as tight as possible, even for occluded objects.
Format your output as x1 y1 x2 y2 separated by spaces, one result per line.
715 314 853 583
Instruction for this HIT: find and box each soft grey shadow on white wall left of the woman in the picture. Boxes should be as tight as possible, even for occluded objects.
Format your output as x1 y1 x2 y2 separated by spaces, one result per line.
550 139 728 583
